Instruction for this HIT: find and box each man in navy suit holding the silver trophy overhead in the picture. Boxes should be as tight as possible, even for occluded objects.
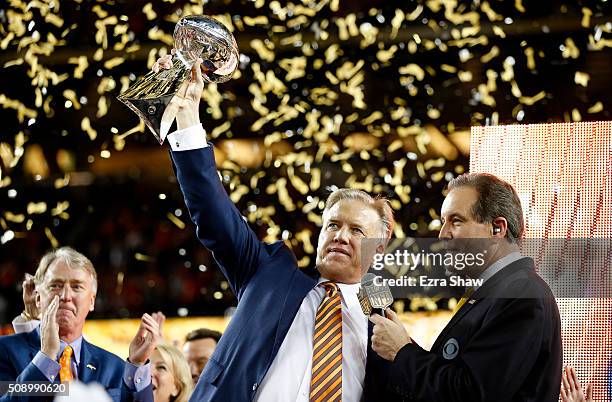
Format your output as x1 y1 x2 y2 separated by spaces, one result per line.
154 56 393 402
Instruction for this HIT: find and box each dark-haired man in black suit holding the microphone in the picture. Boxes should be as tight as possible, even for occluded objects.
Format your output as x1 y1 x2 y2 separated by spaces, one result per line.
370 174 562 402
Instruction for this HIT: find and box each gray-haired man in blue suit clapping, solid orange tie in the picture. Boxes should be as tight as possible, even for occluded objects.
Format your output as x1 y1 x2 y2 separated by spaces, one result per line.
0 247 159 402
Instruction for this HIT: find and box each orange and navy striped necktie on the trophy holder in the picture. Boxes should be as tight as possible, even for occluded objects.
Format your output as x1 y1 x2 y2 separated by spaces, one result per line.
310 282 342 402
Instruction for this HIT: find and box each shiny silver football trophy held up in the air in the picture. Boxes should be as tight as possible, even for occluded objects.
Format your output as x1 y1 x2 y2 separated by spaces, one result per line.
118 15 239 145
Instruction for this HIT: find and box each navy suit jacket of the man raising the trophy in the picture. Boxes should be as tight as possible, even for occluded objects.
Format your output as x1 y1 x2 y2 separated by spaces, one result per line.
171 146 384 402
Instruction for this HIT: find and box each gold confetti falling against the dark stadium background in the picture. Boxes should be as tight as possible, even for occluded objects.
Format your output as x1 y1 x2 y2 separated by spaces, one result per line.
0 0 612 314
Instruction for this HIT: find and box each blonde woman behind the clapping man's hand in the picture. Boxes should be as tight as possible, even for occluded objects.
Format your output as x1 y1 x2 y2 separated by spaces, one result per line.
151 343 193 402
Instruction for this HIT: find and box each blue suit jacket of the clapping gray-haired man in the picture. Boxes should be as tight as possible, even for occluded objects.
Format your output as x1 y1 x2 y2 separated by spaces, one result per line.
0 330 153 402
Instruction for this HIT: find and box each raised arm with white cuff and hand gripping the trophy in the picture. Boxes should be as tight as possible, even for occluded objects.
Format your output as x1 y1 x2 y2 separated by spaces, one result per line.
154 58 265 298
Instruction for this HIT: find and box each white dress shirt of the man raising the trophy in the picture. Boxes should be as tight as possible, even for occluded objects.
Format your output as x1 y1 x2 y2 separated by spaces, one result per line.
168 124 368 402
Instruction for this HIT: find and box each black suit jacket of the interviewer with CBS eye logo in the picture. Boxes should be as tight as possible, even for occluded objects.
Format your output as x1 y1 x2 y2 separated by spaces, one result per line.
388 258 563 402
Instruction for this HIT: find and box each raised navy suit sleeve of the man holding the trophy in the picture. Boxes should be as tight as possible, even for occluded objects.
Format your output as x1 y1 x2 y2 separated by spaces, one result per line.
171 146 263 299
